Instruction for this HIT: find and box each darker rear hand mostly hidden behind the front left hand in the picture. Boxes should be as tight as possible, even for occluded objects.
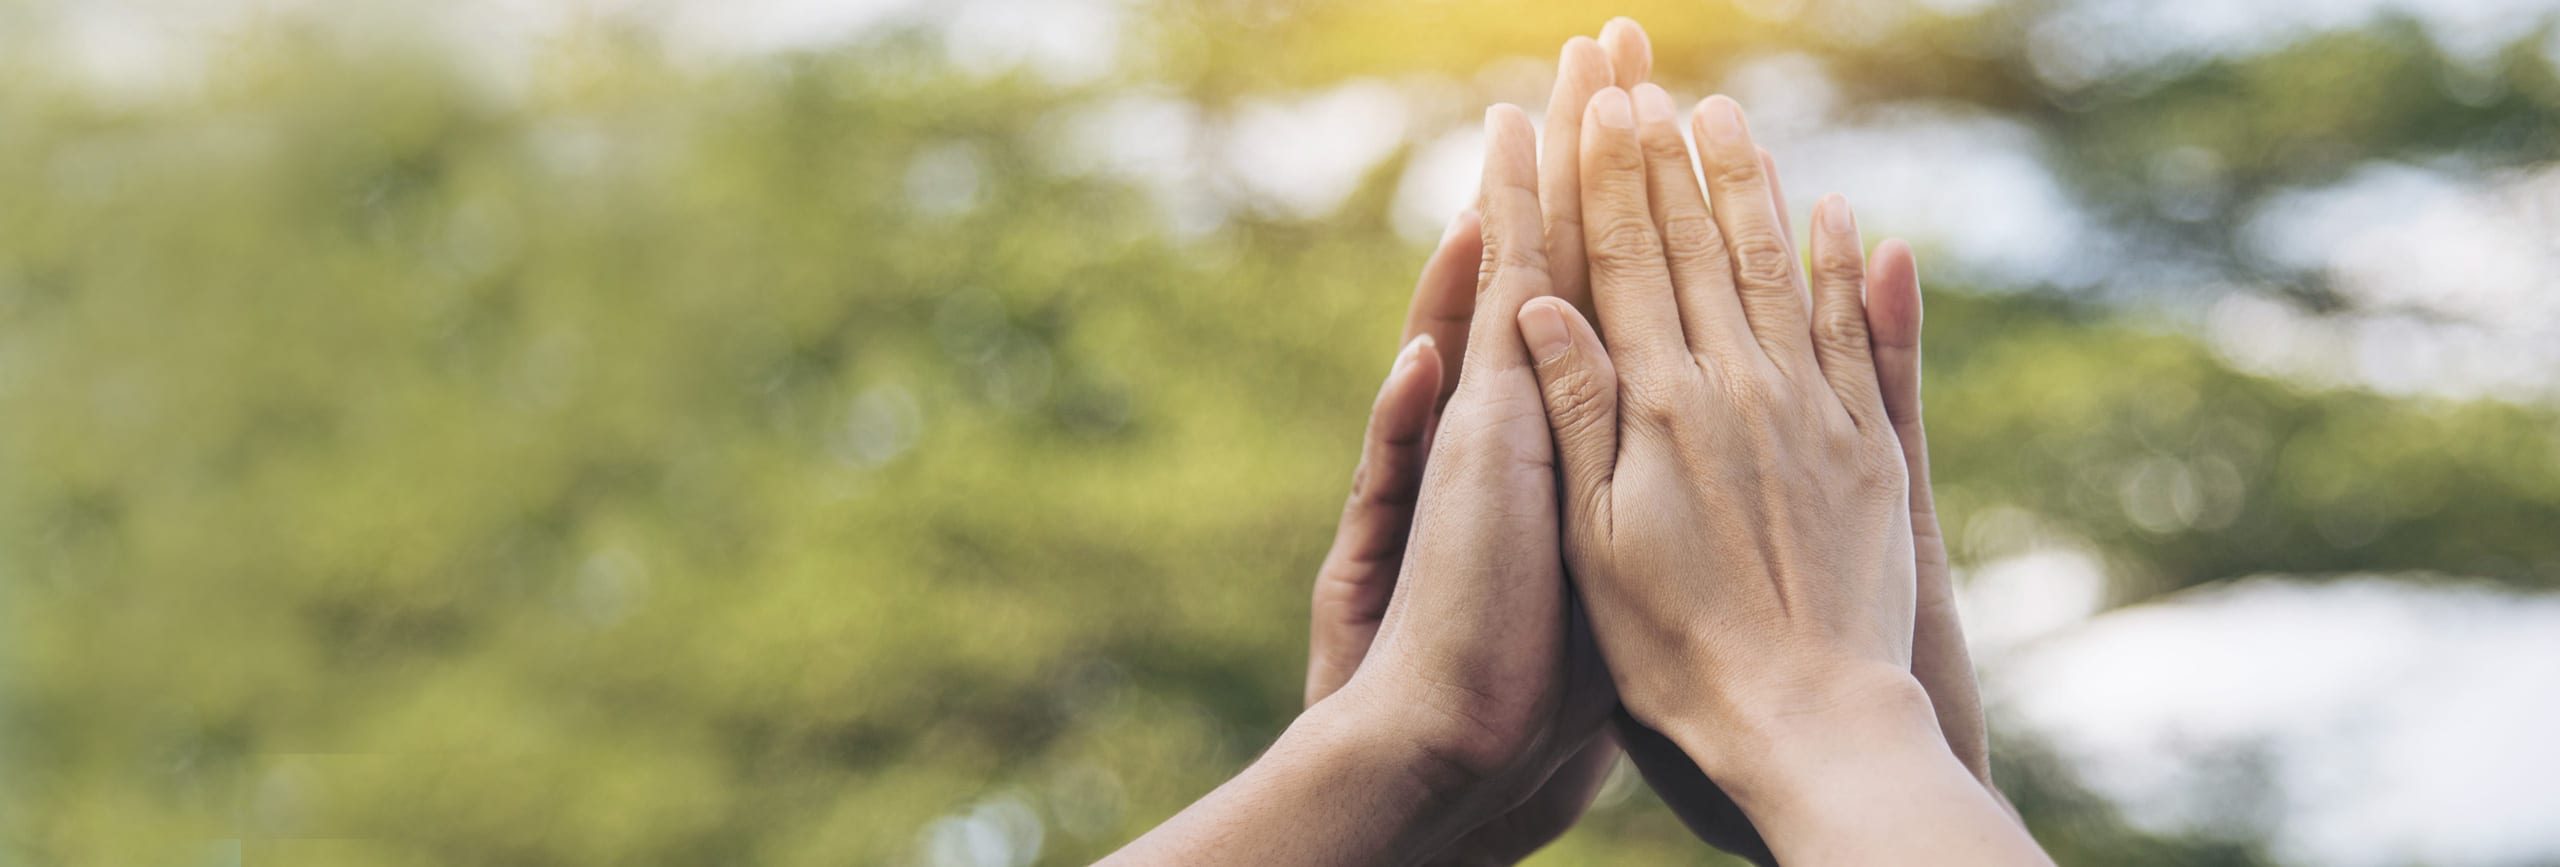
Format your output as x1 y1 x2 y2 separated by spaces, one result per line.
1306 18 1648 864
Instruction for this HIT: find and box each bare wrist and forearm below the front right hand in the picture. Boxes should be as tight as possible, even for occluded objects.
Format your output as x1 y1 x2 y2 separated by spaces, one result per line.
1672 680 2051 867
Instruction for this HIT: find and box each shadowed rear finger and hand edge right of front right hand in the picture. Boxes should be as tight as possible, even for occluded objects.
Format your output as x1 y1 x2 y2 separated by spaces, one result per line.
1866 240 1992 783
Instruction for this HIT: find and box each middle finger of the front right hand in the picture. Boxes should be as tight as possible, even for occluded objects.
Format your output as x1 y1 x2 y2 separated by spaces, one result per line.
1636 84 1764 375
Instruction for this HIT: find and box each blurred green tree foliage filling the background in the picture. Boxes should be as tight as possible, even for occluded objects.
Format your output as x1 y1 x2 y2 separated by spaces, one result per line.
0 3 2560 864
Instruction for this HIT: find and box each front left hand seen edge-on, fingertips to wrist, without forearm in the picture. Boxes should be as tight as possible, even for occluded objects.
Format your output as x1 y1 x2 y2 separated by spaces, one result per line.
1318 105 1615 838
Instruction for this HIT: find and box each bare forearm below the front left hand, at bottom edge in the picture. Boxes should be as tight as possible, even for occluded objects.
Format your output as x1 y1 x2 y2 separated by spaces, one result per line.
1103 701 1469 864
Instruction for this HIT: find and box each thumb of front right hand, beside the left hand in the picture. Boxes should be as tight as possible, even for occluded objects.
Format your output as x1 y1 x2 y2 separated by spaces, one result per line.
1521 299 1618 537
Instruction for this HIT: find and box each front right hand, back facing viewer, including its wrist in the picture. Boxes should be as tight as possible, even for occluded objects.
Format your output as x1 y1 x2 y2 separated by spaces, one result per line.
1521 87 2035 862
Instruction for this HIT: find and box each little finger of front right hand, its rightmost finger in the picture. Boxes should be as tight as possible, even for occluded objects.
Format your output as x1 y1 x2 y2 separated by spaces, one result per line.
1812 194 1887 430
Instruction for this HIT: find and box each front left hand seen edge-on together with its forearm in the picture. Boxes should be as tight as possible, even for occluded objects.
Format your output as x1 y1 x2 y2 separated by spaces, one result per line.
1108 105 1615 864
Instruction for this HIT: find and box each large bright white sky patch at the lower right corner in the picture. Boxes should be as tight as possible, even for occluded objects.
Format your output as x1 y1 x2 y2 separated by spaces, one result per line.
1976 573 2560 864
